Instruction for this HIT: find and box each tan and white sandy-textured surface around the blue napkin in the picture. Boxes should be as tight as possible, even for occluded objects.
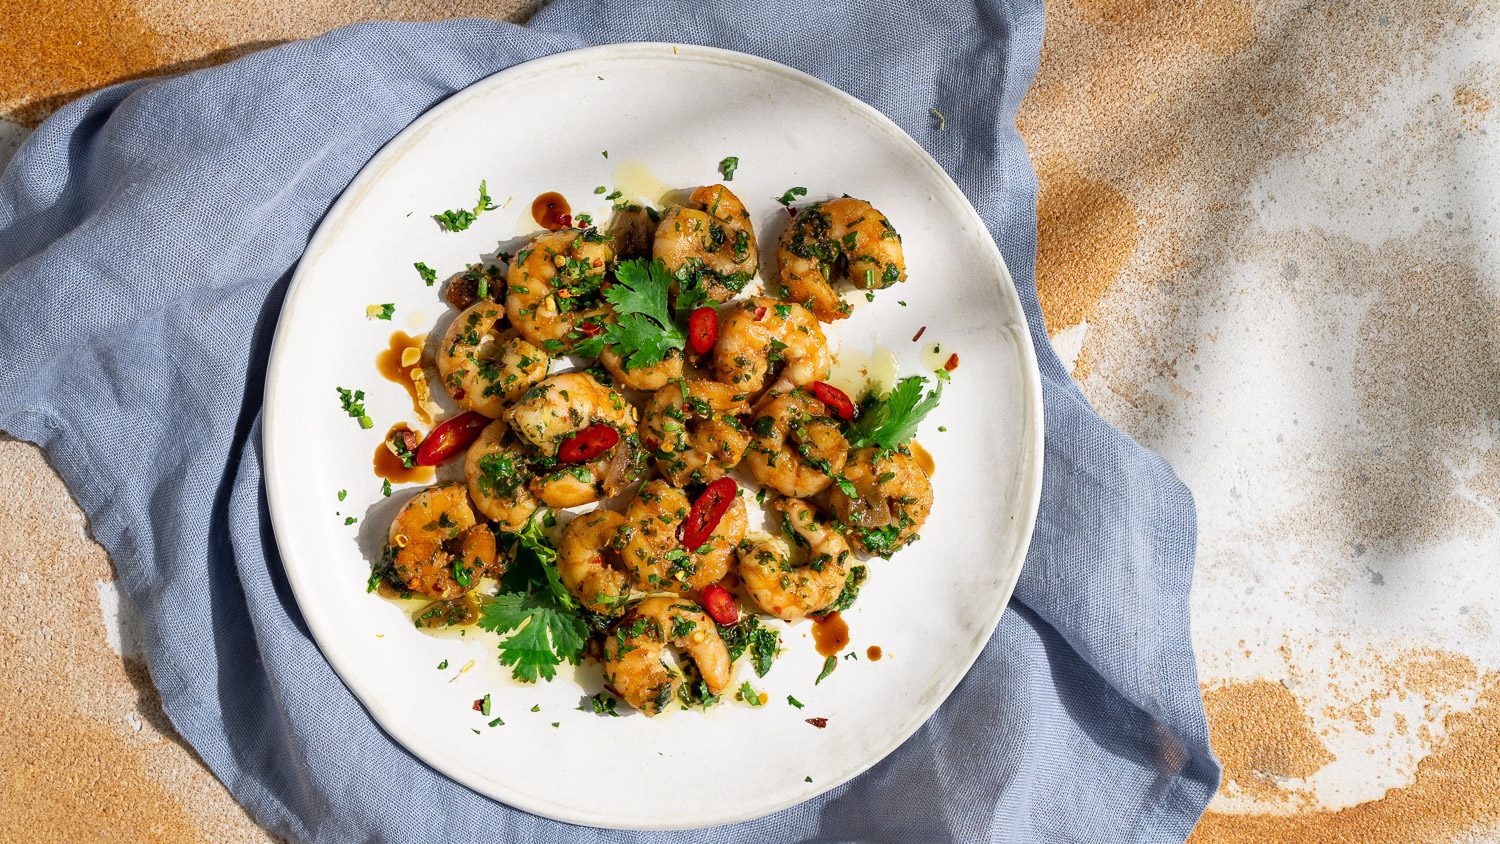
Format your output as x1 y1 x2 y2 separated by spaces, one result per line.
0 0 1500 844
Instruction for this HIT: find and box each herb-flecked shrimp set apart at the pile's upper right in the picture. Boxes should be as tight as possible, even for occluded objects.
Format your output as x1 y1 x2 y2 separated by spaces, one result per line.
777 196 906 322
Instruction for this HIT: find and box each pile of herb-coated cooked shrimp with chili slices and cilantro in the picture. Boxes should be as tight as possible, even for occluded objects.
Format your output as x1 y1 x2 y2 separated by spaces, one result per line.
372 184 945 717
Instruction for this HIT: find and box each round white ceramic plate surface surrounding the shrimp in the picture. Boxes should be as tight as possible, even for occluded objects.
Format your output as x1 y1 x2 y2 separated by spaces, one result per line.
264 43 1043 829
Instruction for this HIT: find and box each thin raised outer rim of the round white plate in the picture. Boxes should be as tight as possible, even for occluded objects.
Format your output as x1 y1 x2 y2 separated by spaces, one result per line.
261 40 1046 831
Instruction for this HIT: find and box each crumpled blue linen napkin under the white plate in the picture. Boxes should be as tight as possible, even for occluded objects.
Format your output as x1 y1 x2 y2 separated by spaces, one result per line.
0 0 1218 843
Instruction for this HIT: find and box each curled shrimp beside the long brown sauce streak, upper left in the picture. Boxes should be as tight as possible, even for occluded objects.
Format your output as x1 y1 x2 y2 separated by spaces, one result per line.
438 300 548 418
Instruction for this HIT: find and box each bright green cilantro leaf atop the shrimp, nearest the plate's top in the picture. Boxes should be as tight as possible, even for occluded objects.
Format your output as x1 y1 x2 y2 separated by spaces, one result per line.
597 258 687 369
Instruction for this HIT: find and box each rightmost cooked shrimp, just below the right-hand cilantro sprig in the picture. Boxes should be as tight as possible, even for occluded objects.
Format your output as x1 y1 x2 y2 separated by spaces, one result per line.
828 448 933 556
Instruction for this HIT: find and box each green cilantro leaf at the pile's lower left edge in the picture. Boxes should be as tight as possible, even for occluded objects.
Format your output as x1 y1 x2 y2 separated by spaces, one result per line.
479 592 588 682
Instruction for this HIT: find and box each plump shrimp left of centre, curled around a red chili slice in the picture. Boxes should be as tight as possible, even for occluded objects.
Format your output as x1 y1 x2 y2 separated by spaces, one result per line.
507 372 645 507
